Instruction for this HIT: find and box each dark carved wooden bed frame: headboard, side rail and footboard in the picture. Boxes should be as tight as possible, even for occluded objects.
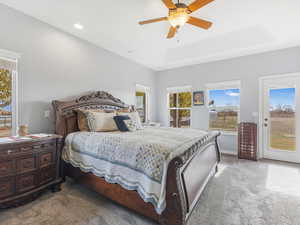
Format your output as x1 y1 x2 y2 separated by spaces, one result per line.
53 92 220 225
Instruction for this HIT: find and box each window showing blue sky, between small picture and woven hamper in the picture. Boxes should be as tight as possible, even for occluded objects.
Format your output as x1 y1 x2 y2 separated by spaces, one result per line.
207 81 240 132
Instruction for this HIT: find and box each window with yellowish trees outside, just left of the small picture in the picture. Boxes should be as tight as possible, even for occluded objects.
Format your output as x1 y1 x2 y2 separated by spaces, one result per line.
168 87 192 128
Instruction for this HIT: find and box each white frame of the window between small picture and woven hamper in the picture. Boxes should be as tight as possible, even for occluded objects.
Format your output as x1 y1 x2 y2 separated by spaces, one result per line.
206 80 241 135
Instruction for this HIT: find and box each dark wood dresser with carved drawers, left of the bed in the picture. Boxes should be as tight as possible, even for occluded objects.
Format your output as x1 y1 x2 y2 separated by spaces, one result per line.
0 135 63 208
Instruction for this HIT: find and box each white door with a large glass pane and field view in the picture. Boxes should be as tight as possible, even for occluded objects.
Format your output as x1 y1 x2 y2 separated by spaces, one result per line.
262 75 300 163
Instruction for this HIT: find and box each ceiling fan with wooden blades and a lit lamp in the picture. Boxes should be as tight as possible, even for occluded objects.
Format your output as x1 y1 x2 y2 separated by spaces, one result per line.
139 0 214 39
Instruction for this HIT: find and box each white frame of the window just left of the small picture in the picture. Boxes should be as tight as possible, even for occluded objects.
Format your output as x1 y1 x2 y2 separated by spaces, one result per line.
167 86 193 128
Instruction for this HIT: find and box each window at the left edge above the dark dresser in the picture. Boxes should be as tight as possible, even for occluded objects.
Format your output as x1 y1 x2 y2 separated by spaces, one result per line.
0 50 17 137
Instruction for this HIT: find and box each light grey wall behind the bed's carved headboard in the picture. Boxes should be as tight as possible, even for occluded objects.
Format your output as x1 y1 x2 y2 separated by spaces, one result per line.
0 4 155 132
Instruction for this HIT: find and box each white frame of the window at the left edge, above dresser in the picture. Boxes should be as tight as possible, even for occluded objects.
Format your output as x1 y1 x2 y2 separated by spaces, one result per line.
0 49 21 136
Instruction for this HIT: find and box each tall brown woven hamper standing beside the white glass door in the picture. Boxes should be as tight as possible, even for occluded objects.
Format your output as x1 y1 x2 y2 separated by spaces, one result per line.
238 122 257 161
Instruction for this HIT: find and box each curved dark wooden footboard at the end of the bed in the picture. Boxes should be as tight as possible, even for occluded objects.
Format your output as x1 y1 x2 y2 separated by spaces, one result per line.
160 133 220 225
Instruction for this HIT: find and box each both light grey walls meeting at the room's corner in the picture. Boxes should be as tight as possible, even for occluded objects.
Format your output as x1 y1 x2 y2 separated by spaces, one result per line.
0 4 300 156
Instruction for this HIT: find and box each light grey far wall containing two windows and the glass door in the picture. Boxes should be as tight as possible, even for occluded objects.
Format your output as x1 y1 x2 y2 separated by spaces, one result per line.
157 47 300 152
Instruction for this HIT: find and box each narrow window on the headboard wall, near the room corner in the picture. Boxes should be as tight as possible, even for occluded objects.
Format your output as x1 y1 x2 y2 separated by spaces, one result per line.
135 84 150 123
